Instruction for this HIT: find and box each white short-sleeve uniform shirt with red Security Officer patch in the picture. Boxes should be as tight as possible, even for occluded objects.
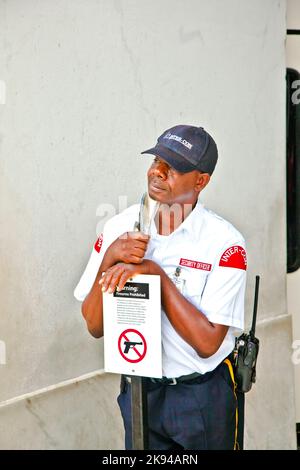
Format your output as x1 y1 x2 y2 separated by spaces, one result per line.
74 201 247 377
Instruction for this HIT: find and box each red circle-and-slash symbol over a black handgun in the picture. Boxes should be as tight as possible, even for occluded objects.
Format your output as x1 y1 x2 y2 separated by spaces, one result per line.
118 329 147 363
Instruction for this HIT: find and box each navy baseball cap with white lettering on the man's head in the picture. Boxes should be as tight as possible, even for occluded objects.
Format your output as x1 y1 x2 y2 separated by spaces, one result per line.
142 125 218 175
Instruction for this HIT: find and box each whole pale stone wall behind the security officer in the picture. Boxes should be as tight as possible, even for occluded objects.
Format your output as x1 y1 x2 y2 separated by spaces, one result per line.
0 0 295 449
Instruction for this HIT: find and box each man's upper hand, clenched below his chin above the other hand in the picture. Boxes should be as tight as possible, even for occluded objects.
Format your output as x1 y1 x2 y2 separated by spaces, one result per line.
105 232 150 265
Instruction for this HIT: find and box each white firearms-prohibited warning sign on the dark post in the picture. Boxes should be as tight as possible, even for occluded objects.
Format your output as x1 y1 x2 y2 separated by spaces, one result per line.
103 275 162 377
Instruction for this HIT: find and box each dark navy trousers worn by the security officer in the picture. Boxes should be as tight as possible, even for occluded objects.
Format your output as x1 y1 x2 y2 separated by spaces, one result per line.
118 363 243 450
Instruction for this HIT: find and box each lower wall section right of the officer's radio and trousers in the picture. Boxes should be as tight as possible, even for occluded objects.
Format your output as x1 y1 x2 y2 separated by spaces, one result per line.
245 316 296 450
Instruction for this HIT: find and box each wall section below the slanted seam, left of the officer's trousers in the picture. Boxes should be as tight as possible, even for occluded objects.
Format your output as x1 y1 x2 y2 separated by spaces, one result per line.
0 374 124 450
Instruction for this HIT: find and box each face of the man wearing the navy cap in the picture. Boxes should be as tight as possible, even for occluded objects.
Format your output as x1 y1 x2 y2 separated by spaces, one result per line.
147 157 210 205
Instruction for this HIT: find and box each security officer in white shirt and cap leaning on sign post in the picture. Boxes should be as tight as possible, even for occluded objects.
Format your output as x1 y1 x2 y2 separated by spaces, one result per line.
74 125 247 450
